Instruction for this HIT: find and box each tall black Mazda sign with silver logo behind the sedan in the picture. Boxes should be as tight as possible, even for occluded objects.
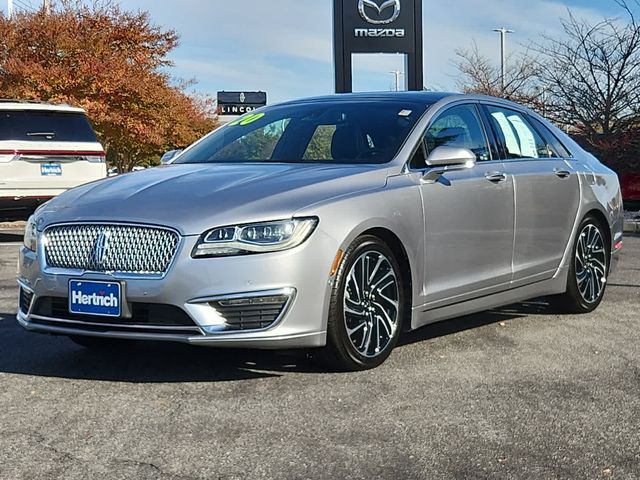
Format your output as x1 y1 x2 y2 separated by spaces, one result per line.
334 0 423 92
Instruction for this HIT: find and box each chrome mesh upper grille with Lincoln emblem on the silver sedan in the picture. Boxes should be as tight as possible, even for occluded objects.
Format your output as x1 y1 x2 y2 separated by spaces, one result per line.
44 224 179 275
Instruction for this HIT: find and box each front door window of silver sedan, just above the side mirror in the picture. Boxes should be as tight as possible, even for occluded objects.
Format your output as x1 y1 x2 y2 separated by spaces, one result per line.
424 105 491 162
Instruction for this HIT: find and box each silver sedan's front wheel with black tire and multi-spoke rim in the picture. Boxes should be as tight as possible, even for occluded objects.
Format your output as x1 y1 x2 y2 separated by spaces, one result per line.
313 235 406 371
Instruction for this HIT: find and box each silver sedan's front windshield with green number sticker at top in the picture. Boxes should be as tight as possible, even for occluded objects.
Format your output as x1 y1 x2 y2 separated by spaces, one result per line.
174 100 429 163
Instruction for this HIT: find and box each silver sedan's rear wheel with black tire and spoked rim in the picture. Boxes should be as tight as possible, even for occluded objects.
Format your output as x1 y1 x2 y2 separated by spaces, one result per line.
550 215 611 313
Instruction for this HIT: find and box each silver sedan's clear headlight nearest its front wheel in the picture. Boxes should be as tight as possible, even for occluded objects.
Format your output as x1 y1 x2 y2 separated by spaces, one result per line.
192 218 318 257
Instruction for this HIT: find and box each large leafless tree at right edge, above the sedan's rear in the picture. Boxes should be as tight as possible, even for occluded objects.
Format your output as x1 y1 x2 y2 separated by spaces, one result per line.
534 0 640 146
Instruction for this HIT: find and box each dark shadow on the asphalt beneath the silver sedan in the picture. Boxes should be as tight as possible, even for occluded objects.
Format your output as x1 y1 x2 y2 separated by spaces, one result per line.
0 303 547 383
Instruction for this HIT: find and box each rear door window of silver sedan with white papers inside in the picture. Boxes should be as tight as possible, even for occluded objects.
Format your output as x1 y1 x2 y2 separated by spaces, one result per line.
487 105 551 159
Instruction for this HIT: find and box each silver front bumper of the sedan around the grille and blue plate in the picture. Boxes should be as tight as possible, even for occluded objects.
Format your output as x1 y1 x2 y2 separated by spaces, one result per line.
17 229 338 349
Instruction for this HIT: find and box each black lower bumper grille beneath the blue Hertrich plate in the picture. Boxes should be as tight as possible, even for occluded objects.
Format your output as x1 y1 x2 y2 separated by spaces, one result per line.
31 297 201 334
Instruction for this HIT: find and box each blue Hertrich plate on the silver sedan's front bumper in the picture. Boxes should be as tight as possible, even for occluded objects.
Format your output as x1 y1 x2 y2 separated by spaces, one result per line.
69 280 122 317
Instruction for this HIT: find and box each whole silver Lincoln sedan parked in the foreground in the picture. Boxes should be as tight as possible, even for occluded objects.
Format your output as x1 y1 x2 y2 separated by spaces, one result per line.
18 92 623 370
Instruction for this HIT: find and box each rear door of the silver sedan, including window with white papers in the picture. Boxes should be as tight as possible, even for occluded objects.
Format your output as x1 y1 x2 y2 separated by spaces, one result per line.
484 105 580 286
